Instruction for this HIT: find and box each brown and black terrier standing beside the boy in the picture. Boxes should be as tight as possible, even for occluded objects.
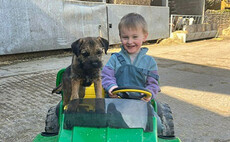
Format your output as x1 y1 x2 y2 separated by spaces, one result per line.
52 37 109 106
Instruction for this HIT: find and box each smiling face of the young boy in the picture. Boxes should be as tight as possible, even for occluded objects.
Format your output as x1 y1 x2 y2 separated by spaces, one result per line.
120 28 148 54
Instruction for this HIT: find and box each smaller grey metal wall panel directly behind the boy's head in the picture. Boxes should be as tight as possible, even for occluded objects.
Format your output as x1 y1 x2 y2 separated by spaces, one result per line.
107 4 169 44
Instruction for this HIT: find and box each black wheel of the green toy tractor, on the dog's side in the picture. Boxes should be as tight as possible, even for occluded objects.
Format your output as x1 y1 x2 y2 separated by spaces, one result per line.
45 106 59 134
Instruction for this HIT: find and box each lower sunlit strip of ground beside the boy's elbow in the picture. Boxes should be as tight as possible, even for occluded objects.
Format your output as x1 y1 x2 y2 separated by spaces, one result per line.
161 86 230 117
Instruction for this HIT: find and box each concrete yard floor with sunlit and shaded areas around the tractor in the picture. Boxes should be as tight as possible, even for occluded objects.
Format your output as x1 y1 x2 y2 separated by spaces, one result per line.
0 39 230 142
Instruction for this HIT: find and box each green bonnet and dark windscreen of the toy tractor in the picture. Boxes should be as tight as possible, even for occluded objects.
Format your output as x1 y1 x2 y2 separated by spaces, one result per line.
59 99 153 142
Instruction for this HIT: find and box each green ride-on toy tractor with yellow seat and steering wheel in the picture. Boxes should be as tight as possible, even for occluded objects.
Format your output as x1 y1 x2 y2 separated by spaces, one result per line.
33 69 180 142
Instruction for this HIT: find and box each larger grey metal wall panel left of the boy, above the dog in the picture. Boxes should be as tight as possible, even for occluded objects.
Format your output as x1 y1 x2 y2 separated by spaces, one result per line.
0 0 108 55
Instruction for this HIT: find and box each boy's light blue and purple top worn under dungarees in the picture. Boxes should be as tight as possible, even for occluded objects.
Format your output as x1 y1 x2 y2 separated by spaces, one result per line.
102 46 160 98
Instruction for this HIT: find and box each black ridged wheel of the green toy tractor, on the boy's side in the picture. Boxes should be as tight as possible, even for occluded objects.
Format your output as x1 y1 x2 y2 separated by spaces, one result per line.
157 102 174 137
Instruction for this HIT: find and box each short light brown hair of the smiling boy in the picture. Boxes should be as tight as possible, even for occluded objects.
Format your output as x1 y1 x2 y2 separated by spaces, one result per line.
118 13 148 35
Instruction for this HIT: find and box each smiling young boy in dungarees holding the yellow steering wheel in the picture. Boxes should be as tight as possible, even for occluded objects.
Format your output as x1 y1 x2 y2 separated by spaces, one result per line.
102 13 160 102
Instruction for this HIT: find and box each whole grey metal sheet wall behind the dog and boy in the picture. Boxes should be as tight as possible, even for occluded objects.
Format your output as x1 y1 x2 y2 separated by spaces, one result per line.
0 0 169 55
